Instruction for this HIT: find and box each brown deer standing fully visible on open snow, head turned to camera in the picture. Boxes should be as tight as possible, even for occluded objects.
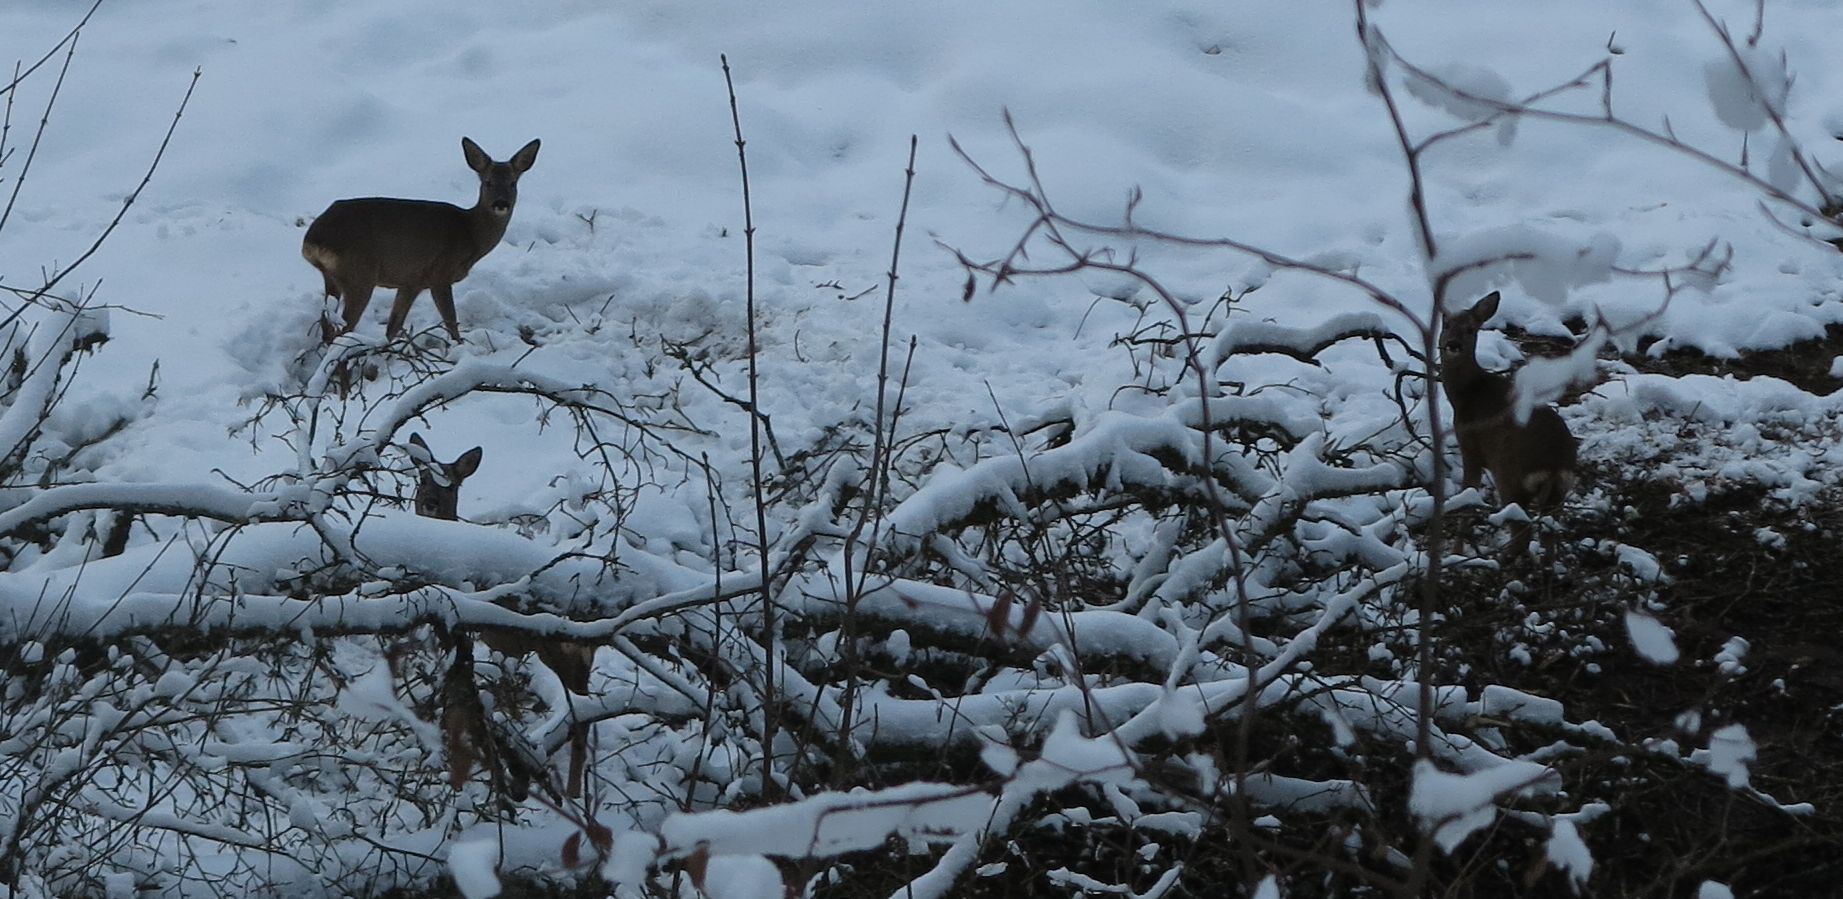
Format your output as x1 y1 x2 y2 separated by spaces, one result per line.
300 138 538 343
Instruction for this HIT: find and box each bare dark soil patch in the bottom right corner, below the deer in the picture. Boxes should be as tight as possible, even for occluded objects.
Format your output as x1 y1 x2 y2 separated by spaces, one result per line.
1443 469 1843 897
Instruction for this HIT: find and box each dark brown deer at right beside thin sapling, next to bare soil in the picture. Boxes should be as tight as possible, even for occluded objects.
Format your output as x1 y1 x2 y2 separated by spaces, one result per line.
1439 291 1576 556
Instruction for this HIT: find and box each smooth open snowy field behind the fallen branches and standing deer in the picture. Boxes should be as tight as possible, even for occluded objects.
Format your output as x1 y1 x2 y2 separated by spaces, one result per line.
0 2 1843 490
